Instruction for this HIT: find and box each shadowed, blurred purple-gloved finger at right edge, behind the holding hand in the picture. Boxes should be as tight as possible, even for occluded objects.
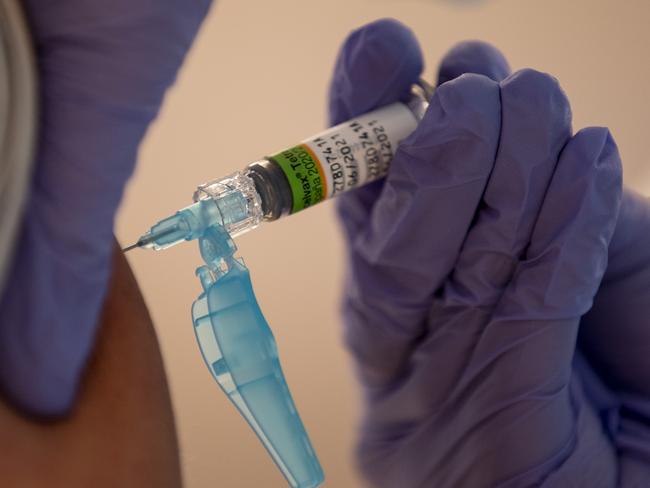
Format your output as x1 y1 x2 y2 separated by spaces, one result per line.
579 190 650 398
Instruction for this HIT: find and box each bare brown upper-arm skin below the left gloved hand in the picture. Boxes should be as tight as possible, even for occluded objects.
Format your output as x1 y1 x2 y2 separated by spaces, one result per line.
0 247 182 488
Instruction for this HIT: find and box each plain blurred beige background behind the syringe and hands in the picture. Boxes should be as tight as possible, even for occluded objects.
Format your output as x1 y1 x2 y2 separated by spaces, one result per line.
118 0 650 488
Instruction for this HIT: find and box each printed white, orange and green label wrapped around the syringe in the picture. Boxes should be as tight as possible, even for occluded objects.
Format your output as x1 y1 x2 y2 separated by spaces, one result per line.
270 103 418 213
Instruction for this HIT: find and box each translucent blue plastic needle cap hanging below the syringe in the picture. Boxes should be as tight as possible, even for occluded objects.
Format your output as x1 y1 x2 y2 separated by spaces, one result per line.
192 259 323 488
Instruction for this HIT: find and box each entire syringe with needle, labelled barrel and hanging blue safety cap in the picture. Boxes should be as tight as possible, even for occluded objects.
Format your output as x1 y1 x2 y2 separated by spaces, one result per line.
125 82 431 488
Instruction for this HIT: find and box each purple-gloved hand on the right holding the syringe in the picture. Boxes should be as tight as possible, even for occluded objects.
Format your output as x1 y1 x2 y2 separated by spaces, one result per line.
330 20 650 488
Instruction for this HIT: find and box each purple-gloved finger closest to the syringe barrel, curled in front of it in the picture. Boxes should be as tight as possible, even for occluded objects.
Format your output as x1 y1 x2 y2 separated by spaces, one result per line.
344 75 501 386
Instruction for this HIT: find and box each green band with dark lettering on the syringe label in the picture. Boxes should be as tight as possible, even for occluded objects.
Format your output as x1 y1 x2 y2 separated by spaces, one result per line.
270 145 325 213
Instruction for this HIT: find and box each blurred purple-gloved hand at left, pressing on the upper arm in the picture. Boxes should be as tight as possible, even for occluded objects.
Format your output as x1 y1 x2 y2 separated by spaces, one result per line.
0 0 211 415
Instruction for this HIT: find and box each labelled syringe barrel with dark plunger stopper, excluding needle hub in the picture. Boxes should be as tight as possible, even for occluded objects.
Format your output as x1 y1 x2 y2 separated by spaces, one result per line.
245 88 428 220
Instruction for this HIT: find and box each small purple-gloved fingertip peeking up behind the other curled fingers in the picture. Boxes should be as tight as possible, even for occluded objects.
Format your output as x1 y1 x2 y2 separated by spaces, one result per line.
438 41 510 85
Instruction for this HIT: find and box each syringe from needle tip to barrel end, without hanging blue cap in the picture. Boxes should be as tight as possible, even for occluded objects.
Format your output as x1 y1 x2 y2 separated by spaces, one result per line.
124 81 433 251
